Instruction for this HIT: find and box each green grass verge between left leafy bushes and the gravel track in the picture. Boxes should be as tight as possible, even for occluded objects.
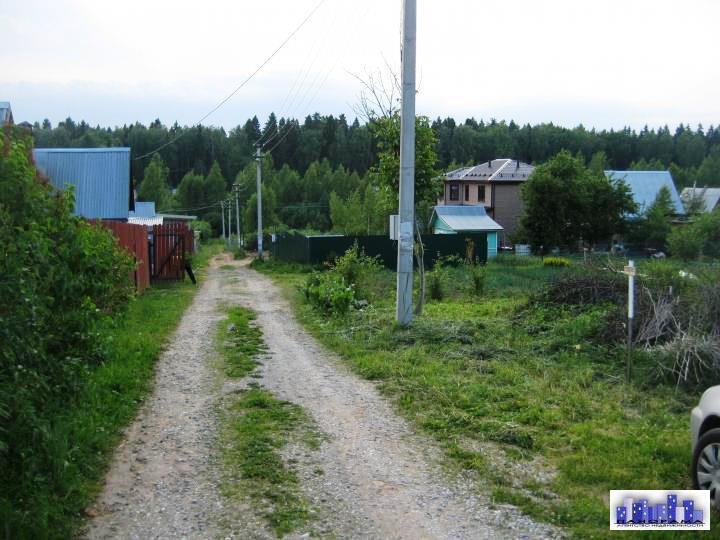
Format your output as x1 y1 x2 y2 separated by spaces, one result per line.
0 244 222 539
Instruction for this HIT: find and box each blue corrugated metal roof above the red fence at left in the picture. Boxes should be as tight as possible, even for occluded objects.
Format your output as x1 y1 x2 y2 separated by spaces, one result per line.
33 148 130 219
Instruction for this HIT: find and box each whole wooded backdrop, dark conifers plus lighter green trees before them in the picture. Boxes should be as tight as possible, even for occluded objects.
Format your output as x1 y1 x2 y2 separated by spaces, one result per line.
33 114 720 234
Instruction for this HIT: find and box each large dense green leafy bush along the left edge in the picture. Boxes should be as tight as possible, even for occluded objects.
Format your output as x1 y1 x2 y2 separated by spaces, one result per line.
0 128 133 537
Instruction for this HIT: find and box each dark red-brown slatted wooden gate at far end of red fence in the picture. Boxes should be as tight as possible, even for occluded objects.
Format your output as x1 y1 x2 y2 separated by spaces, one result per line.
151 223 194 280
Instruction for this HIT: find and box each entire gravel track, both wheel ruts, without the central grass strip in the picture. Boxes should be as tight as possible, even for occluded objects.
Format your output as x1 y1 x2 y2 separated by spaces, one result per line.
87 260 560 539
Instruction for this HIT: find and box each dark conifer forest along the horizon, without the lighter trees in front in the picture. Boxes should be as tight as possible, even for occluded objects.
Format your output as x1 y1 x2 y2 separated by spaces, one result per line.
33 113 720 188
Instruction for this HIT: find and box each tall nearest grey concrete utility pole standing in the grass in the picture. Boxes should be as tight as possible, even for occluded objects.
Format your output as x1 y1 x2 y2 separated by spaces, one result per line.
395 0 417 326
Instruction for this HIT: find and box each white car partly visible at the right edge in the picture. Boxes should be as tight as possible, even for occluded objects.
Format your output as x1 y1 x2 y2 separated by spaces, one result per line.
690 386 720 507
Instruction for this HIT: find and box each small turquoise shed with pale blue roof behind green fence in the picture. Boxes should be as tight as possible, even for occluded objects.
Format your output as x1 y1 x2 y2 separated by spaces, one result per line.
430 204 503 258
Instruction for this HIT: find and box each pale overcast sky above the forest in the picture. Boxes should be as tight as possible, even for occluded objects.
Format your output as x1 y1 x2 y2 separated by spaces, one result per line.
0 0 720 128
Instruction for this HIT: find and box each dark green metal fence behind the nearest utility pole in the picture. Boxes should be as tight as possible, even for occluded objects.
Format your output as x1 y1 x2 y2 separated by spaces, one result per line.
270 233 487 268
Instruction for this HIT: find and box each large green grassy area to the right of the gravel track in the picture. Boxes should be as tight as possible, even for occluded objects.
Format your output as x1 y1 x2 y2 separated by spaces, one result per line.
256 258 716 538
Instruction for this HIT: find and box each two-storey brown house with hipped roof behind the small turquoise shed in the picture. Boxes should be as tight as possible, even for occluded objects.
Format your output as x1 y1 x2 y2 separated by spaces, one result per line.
440 159 535 244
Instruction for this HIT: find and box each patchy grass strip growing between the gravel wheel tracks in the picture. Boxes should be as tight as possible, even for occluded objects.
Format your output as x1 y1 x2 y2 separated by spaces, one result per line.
217 306 318 537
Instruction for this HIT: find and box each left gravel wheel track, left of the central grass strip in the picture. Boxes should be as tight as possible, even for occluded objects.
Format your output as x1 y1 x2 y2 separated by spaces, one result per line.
86 262 242 539
